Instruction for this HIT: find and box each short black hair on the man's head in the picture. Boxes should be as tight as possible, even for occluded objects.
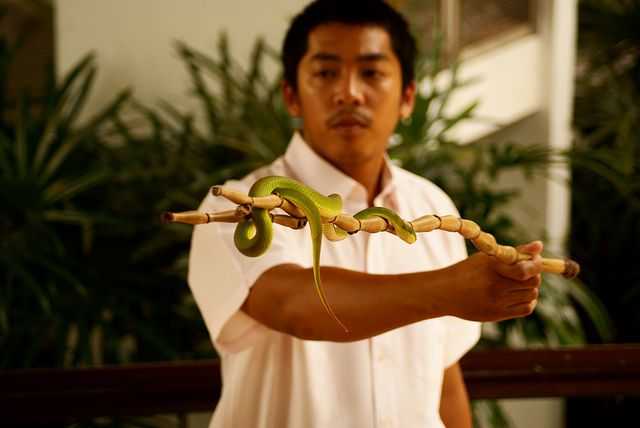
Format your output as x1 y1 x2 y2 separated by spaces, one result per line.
282 0 417 90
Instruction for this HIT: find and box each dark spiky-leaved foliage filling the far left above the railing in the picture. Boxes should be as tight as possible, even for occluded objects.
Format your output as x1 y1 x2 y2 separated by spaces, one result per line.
0 35 212 368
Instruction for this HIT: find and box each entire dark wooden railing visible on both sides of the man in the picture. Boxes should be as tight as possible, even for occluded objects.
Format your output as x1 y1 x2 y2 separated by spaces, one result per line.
0 345 640 426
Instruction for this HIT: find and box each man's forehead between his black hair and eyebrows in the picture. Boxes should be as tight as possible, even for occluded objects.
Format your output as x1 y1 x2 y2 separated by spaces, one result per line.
305 23 393 59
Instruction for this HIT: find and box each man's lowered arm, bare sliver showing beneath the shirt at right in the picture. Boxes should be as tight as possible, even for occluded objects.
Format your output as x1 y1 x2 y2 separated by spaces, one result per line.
440 363 472 428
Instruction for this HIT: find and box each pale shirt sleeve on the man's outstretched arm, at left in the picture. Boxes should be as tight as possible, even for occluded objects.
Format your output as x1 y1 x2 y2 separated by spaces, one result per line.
188 186 298 354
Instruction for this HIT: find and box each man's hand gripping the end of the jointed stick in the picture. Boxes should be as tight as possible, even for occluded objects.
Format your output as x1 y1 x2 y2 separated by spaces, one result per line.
445 241 543 321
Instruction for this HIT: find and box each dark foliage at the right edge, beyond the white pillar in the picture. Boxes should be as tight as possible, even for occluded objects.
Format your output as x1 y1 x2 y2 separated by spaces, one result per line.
567 0 640 426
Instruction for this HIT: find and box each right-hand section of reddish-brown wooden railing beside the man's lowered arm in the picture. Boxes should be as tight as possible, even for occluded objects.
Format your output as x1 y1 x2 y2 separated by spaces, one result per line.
461 345 640 399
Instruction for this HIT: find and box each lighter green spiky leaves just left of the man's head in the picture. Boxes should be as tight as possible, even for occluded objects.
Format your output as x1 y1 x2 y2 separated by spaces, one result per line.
168 34 293 181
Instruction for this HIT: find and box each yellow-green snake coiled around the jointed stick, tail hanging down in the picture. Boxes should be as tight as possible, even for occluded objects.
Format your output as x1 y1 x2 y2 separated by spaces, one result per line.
233 176 416 332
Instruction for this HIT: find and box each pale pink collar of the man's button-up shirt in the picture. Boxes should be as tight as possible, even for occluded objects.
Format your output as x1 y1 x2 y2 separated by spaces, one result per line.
284 132 395 207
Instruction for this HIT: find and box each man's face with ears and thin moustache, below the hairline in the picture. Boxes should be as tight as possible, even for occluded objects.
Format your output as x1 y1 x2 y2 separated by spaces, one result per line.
284 23 415 170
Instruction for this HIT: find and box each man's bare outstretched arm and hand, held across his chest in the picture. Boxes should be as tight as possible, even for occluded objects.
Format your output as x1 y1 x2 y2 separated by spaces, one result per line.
242 242 542 342
